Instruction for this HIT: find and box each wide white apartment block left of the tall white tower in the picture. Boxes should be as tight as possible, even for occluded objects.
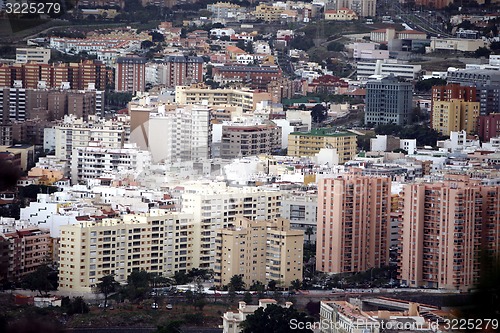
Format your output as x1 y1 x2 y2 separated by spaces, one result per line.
52 116 130 160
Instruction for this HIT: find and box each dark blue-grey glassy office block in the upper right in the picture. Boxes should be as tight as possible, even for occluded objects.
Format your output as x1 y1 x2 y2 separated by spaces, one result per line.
365 76 413 125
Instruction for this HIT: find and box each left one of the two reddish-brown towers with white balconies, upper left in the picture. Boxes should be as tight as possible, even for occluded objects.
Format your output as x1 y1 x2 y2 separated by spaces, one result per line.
115 57 146 94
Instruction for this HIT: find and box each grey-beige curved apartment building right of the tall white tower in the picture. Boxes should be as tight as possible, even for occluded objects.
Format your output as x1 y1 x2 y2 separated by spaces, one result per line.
220 122 281 158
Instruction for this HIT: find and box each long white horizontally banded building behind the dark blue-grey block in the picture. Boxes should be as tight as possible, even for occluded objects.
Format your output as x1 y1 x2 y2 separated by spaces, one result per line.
356 59 422 81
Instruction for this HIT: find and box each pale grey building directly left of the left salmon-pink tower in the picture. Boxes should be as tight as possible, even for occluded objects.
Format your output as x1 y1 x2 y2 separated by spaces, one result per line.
280 191 318 242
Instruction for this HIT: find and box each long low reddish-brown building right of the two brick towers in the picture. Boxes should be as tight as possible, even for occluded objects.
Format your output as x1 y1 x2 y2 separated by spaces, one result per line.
212 65 283 89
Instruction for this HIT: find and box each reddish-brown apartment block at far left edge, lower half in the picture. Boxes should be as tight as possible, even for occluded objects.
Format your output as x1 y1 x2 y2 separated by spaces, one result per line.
3 228 51 282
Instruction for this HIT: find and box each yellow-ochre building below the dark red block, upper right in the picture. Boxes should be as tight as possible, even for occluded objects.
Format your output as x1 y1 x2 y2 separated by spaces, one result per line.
431 99 480 135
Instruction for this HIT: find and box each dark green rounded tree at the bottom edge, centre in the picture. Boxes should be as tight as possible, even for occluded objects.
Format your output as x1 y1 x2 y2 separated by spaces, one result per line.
240 304 314 333
